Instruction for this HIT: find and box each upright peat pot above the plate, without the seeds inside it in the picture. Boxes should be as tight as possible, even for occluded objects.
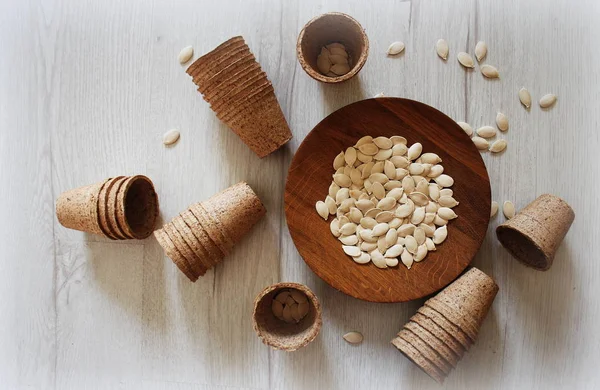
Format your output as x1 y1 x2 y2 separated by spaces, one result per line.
296 12 369 84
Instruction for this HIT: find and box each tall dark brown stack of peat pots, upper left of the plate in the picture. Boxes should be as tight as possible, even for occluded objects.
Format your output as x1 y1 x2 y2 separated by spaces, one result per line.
187 36 292 158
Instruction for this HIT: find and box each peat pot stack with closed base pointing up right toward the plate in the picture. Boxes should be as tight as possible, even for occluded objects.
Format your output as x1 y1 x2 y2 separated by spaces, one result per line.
154 182 266 282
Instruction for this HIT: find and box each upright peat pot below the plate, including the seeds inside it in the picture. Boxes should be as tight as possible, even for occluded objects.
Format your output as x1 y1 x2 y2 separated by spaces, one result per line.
253 283 323 351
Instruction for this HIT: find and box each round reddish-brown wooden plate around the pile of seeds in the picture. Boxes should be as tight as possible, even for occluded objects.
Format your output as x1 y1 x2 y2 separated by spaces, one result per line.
285 98 491 302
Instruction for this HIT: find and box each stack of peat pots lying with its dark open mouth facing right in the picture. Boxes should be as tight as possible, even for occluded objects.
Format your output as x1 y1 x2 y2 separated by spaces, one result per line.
56 175 158 240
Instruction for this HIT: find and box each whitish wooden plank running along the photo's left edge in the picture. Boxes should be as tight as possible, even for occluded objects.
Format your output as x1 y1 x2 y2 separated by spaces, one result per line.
0 2 56 389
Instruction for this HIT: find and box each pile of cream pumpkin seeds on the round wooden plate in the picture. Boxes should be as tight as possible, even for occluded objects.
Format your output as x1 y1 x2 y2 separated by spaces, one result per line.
316 136 458 269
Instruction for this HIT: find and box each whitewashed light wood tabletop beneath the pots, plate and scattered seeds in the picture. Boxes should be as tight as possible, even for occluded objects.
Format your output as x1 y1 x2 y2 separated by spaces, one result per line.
0 0 600 390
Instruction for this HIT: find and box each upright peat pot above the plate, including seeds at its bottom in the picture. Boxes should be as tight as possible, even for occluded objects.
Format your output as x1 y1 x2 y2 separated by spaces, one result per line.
296 12 369 83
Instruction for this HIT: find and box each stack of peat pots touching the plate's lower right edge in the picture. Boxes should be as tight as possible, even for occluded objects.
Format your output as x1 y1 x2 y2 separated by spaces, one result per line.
392 268 498 383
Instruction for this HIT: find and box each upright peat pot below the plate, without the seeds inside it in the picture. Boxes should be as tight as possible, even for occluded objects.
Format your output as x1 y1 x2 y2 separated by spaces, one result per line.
253 283 323 352
